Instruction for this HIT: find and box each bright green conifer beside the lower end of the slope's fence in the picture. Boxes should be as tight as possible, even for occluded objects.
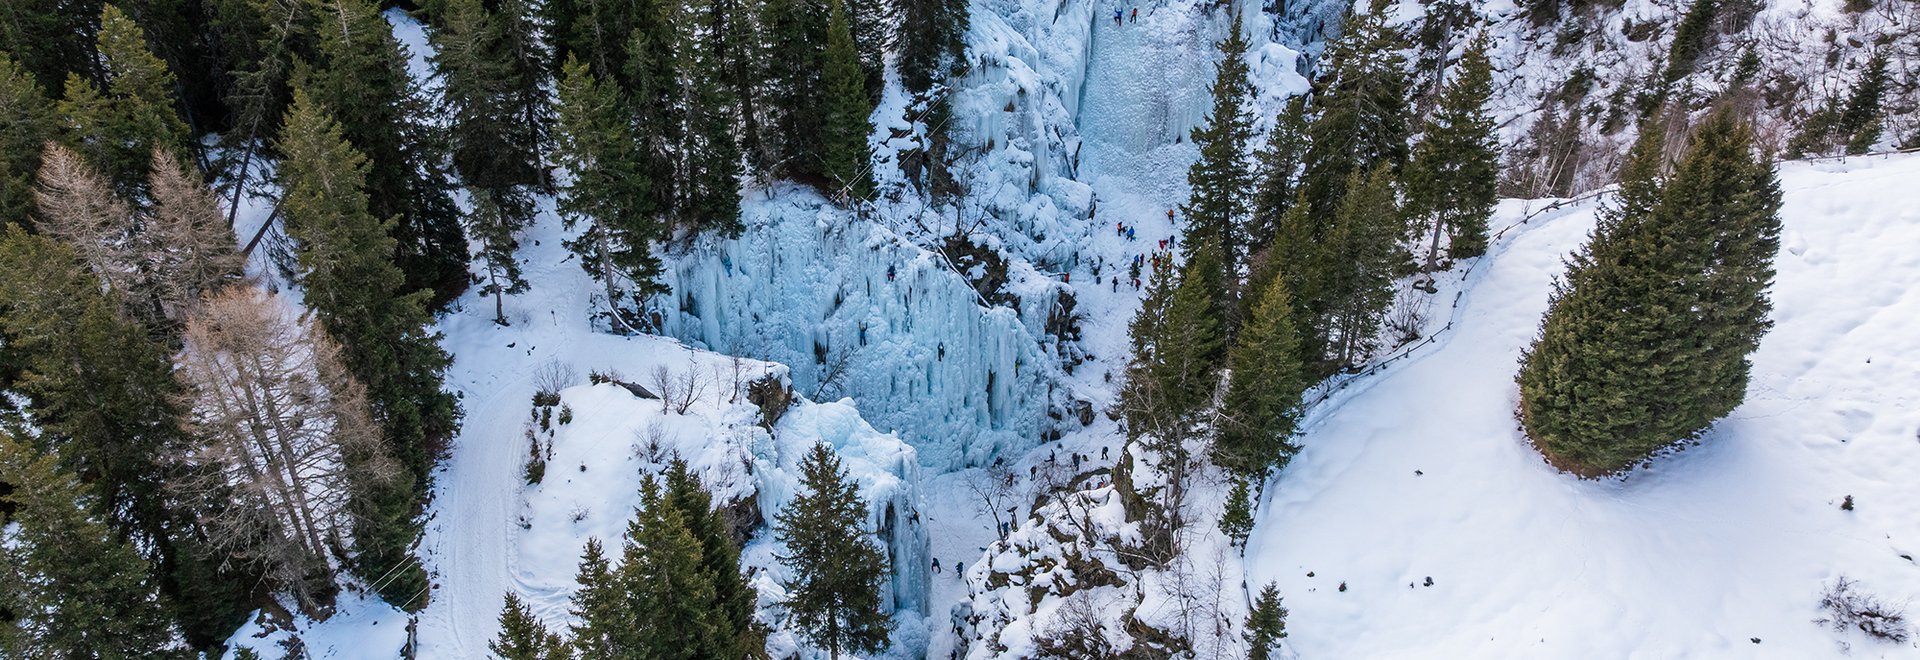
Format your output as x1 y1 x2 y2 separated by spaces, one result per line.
1213 270 1309 478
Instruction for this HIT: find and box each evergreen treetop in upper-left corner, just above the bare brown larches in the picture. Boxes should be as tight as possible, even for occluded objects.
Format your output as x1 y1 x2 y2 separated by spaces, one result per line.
60 4 188 200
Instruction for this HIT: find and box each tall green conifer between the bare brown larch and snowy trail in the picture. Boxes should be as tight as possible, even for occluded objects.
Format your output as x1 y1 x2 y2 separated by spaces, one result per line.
276 90 459 606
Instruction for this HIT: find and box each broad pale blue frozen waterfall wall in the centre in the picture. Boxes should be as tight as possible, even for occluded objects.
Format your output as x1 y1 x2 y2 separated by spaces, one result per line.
662 186 1054 468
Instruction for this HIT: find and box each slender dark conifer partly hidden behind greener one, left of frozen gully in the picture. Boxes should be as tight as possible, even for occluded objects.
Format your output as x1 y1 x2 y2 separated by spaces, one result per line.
664 459 766 658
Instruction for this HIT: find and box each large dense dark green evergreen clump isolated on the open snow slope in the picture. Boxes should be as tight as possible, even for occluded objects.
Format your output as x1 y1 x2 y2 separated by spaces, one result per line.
1519 111 1780 476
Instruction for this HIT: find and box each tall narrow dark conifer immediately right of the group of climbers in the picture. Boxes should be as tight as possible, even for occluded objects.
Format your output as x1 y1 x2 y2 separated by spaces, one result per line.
1181 13 1254 324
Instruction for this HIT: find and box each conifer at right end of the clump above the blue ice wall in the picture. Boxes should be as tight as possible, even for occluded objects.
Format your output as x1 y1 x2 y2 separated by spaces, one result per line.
820 0 874 200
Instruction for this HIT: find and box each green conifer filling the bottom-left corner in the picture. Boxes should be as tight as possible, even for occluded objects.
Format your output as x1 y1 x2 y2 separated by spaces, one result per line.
0 434 188 658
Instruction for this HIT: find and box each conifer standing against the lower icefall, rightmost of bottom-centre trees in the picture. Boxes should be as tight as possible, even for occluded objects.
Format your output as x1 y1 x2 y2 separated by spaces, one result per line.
774 443 893 658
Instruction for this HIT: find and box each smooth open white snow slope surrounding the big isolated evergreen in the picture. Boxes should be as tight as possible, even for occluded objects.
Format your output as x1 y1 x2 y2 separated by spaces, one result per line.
1246 157 1920 658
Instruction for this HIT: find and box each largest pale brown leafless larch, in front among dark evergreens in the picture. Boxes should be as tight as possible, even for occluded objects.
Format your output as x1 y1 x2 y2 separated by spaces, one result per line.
173 286 399 612
